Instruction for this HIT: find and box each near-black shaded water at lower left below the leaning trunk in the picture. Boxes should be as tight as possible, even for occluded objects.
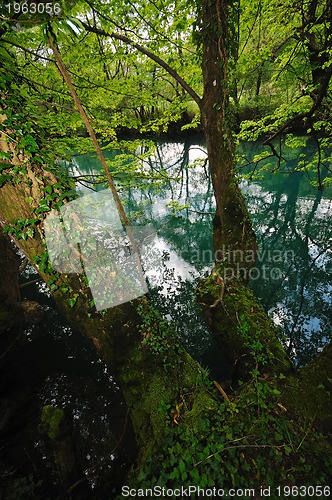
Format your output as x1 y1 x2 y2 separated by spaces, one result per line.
0 266 136 499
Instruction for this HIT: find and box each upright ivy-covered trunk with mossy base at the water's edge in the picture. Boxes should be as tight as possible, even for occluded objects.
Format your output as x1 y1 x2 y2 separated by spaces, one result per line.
198 0 291 378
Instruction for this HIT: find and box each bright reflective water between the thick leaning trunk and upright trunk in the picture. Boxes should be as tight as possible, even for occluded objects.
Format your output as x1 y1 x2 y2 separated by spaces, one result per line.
120 141 214 358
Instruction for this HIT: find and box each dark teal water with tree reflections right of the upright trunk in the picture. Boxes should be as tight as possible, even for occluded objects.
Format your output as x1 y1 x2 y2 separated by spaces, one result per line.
237 139 332 365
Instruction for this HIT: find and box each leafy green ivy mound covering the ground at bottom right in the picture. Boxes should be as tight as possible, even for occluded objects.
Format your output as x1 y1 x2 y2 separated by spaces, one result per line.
129 368 332 490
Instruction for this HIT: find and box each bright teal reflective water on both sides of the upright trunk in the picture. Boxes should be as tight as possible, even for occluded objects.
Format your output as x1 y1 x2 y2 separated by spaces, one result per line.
69 138 332 364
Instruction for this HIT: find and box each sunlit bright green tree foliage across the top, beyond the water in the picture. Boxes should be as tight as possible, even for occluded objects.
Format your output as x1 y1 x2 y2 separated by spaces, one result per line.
0 0 332 187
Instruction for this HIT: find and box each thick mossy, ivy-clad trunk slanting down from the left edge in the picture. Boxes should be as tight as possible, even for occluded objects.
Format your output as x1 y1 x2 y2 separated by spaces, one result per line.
0 69 215 460
